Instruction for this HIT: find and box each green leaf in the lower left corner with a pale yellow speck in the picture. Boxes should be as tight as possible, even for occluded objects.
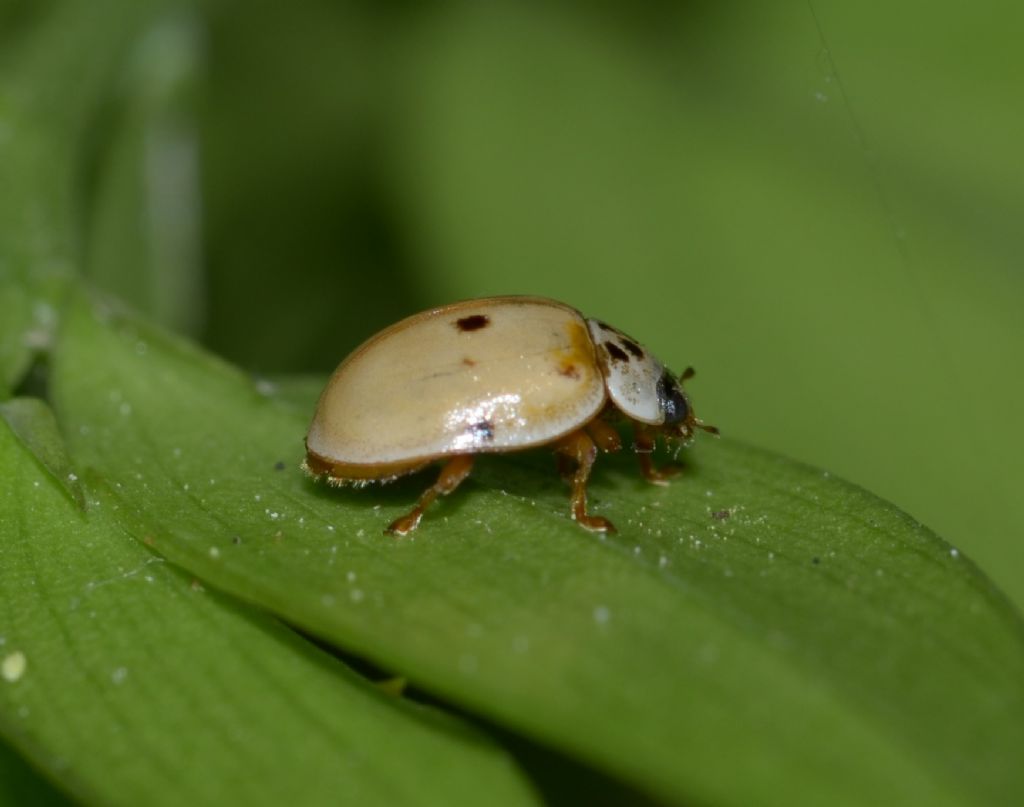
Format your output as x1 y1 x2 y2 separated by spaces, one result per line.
0 399 535 805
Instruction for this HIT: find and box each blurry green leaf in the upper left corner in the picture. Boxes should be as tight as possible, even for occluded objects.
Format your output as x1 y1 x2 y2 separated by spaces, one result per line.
0 0 163 395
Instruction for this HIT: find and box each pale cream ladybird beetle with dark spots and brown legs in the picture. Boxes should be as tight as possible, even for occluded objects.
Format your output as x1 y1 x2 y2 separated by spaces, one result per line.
303 297 718 535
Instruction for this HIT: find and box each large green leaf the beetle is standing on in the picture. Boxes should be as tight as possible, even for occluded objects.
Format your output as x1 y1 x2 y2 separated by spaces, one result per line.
54 286 1024 805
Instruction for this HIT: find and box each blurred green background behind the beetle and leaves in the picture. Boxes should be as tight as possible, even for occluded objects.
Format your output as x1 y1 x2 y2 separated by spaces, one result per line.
54 0 1024 603
